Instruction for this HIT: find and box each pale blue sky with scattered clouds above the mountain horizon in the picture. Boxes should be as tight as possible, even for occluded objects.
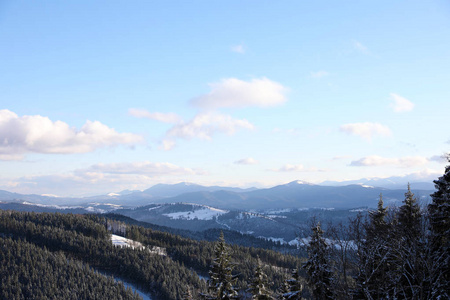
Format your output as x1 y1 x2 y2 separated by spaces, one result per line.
0 0 450 196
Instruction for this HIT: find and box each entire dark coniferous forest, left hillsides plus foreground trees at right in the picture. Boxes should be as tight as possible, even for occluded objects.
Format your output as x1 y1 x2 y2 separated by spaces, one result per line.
0 156 450 299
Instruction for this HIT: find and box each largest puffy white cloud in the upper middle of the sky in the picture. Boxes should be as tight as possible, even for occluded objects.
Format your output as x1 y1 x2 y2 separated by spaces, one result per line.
191 78 287 109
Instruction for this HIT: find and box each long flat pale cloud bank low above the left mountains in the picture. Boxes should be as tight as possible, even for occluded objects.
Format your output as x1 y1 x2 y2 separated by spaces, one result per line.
0 162 207 197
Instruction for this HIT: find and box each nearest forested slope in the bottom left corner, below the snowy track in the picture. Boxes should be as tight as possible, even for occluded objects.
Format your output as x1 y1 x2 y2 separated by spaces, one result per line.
0 237 142 299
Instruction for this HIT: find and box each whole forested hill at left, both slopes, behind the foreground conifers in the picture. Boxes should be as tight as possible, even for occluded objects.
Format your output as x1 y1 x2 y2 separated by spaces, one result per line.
0 211 302 299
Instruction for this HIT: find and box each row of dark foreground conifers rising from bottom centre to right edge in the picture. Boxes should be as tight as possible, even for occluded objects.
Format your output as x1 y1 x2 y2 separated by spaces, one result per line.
198 158 450 300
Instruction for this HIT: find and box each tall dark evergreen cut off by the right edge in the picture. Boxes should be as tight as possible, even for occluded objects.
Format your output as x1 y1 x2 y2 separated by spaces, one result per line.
428 154 450 299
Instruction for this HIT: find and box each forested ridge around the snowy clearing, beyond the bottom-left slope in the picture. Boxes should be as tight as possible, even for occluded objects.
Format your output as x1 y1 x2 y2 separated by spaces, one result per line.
0 211 301 300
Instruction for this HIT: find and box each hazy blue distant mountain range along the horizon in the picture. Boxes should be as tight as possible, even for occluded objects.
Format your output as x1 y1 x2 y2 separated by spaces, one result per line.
0 181 433 211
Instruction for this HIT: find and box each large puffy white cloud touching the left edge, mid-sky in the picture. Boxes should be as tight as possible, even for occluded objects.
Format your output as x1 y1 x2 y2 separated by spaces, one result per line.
0 109 143 158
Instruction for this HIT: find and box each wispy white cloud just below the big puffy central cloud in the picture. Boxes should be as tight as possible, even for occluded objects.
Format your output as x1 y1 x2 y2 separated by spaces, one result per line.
166 112 254 146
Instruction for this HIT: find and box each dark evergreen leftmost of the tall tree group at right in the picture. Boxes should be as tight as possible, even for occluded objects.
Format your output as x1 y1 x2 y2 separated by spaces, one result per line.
303 223 334 299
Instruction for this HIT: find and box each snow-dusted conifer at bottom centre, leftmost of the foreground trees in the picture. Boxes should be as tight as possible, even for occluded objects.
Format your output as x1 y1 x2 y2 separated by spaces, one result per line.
202 232 239 300
